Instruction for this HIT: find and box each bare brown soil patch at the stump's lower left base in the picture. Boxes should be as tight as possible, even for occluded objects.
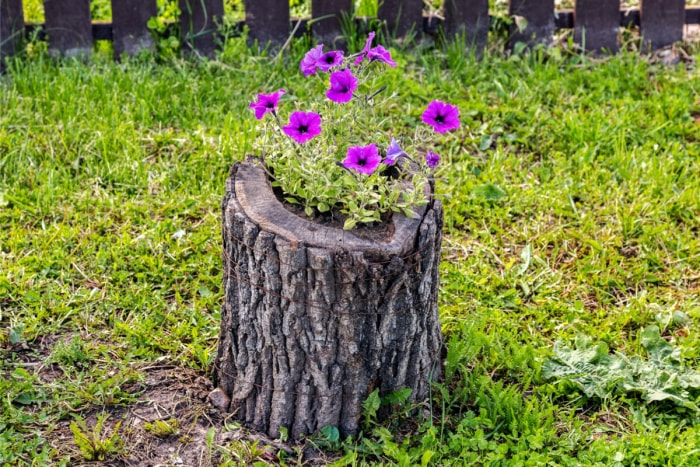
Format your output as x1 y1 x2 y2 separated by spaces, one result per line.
48 365 325 467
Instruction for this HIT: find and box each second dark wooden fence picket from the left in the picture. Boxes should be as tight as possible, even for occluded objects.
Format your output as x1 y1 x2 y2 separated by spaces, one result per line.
44 0 92 57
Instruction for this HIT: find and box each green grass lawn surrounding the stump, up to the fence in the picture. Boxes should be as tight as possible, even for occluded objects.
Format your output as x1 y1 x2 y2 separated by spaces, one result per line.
0 31 700 466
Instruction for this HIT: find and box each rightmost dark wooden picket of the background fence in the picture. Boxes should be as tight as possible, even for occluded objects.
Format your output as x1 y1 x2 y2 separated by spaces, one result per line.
640 0 685 50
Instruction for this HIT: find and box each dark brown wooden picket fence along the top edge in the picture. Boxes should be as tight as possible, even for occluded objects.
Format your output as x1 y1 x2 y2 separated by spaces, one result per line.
0 0 700 62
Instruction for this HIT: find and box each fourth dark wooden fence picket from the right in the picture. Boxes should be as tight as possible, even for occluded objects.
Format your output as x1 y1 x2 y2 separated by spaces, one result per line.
444 0 489 56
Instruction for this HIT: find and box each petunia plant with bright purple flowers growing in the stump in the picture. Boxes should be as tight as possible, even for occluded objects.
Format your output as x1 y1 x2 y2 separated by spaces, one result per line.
250 32 460 229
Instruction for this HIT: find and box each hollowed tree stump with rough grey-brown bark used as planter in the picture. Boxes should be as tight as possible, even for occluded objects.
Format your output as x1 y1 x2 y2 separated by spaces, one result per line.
212 162 443 439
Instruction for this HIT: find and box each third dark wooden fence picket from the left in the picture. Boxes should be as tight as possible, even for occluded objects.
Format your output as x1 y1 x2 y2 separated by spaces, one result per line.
112 0 158 60
